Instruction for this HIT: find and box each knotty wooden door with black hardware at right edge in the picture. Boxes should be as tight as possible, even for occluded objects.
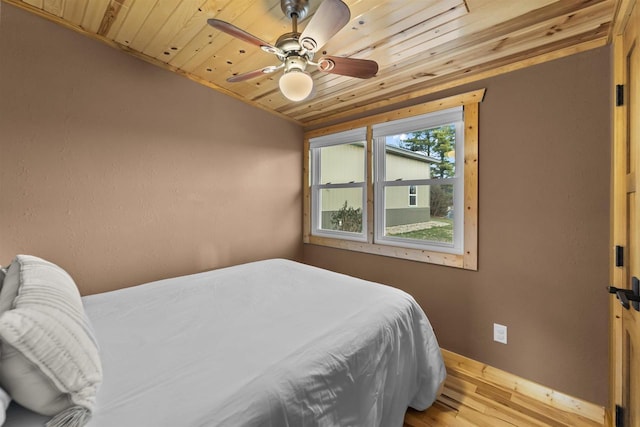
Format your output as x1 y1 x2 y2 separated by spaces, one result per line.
611 0 640 427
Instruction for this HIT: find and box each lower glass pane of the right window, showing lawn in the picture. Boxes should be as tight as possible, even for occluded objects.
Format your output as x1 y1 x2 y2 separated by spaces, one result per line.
384 184 453 244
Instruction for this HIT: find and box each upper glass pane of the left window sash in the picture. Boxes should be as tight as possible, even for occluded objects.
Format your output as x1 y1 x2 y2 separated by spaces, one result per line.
318 143 365 184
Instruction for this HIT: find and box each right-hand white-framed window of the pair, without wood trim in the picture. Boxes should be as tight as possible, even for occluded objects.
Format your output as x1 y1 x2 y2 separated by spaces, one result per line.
373 107 464 254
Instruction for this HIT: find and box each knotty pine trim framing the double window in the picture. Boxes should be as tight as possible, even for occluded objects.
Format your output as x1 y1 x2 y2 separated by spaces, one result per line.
302 89 486 271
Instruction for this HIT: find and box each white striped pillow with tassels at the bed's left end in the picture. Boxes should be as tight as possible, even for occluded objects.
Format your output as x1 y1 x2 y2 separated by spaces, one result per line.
0 255 102 427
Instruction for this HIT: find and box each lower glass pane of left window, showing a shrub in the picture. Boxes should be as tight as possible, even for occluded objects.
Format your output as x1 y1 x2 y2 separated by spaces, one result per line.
320 188 363 233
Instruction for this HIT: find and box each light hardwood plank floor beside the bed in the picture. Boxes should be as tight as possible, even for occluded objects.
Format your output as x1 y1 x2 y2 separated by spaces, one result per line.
404 355 603 427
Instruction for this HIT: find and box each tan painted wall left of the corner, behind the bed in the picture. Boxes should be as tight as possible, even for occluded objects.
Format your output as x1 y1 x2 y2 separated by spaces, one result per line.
0 4 302 294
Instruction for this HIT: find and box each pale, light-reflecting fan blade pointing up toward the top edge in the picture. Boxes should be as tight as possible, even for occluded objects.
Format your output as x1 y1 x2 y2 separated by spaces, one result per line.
300 0 351 52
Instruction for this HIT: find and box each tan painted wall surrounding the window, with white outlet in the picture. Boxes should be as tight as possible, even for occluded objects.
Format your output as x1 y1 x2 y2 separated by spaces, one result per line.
304 48 611 404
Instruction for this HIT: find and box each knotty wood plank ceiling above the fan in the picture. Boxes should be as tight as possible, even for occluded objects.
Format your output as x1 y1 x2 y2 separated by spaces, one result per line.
3 0 619 127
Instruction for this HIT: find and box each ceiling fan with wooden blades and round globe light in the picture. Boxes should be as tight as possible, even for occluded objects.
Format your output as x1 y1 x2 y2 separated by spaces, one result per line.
207 0 378 101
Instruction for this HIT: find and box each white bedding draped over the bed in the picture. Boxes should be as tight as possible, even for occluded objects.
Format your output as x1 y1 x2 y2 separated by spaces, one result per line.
5 260 445 427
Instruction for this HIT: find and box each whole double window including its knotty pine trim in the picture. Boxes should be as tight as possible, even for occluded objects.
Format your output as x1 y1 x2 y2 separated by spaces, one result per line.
304 90 484 270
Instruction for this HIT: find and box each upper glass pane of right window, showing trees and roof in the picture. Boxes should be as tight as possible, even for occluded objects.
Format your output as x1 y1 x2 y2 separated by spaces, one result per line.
385 124 456 181
